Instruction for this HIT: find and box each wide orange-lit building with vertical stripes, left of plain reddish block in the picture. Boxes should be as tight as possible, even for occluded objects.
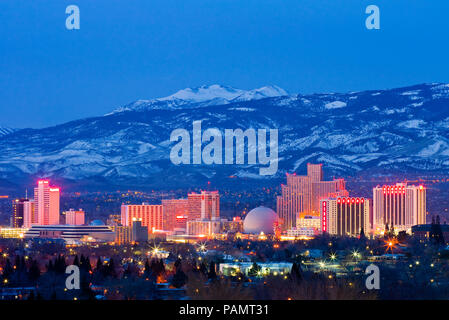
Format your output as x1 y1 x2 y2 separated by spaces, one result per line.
121 203 163 233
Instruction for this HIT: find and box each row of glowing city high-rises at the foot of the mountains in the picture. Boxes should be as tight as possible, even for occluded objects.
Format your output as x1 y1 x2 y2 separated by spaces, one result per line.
1 163 434 242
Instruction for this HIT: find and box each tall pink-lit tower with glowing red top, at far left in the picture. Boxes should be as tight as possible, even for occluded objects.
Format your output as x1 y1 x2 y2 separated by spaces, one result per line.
34 180 60 225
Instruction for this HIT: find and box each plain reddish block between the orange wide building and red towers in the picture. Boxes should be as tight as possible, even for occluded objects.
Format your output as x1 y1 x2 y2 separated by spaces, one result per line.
162 199 189 231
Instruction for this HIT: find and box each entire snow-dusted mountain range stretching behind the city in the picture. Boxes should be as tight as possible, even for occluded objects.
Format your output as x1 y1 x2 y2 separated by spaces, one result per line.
0 84 449 188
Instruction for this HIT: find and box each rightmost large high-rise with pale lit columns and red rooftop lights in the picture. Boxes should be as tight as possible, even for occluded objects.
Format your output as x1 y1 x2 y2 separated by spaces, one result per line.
373 183 426 232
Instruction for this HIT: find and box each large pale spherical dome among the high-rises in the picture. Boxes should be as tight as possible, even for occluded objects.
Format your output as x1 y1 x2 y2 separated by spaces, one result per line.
243 207 278 234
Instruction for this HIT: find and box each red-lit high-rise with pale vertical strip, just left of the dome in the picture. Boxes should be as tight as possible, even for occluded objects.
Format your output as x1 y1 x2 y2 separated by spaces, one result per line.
187 191 220 221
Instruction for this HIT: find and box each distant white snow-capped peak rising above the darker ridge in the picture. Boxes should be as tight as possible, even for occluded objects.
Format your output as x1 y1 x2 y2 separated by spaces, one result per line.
108 84 288 115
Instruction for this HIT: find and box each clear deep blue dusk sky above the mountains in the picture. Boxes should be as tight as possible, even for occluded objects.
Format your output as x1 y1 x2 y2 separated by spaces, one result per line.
0 0 449 128
